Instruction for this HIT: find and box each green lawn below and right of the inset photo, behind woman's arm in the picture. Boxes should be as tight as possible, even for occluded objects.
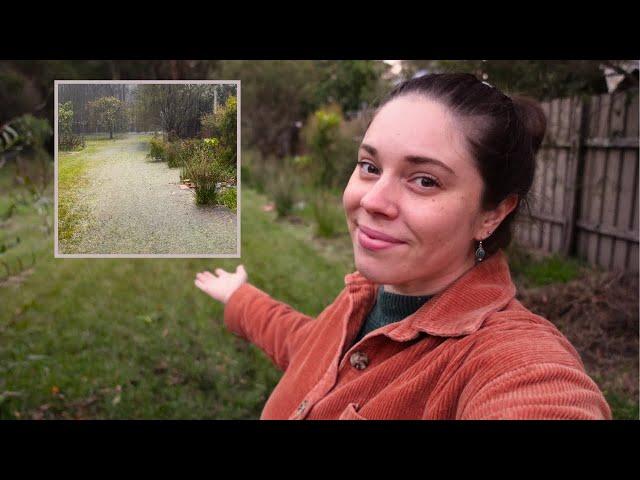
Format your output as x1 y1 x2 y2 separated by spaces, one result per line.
0 162 348 419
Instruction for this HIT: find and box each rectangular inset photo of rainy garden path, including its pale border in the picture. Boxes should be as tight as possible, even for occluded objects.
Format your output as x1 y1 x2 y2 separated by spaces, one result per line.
54 80 240 258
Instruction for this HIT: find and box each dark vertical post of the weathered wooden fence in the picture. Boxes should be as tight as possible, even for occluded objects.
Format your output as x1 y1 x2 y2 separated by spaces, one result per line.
562 98 589 256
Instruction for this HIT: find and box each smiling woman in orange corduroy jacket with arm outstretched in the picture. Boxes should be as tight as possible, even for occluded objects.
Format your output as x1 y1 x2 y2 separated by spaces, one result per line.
195 74 611 420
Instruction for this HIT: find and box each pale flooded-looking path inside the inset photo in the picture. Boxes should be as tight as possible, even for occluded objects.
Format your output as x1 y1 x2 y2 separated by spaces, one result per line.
63 135 237 255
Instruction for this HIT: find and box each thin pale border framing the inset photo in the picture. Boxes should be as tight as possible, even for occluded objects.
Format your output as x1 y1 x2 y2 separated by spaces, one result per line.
53 80 242 258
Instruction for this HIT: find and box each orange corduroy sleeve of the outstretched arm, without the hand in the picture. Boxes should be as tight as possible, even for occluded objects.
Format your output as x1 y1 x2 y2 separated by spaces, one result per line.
224 283 313 371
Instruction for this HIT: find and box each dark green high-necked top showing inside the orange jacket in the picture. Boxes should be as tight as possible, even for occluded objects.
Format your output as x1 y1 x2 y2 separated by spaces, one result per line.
353 285 433 344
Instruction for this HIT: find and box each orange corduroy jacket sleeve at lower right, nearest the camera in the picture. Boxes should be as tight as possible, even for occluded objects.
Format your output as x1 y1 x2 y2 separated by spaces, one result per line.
458 363 611 420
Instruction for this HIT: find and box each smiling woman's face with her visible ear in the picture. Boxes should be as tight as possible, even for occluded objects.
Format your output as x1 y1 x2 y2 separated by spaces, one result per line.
343 95 491 295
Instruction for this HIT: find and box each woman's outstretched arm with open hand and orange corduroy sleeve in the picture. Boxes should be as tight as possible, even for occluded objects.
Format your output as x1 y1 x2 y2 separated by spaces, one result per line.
195 265 312 371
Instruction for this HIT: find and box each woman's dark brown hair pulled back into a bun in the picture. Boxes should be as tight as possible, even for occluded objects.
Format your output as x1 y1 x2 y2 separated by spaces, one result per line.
378 73 547 255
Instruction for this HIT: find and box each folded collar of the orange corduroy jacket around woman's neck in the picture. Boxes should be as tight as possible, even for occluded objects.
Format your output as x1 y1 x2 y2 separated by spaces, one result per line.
345 250 516 341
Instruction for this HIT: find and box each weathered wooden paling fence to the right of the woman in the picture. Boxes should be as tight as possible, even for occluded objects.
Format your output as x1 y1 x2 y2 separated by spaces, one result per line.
515 90 639 271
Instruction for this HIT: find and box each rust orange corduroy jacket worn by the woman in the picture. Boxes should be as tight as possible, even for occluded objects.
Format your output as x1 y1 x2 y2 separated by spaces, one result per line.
224 250 611 420
